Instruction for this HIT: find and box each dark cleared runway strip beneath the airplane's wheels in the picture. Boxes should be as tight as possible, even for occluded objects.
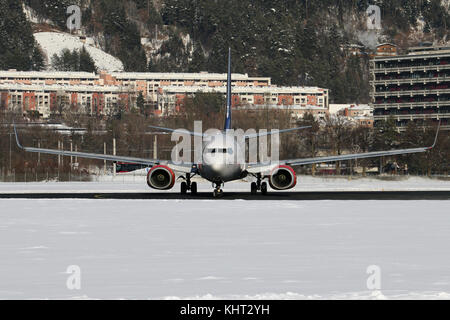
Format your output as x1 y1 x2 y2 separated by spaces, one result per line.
0 191 450 201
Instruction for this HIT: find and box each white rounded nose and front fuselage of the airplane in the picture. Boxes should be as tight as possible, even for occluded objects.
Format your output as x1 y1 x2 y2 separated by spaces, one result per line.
198 132 245 183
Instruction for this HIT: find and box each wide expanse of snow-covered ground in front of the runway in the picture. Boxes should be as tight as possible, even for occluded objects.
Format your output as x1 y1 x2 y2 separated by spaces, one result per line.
0 198 450 299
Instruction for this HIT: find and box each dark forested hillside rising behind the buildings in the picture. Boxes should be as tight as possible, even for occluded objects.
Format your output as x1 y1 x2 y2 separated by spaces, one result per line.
0 0 450 102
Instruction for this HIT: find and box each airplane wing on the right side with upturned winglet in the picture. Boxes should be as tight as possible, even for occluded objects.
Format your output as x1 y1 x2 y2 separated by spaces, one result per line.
247 124 440 174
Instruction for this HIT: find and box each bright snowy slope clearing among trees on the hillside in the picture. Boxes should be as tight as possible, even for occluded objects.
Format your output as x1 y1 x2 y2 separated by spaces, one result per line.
34 32 123 72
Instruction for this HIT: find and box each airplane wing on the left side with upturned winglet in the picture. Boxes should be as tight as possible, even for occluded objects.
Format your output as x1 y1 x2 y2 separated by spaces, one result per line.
14 125 193 173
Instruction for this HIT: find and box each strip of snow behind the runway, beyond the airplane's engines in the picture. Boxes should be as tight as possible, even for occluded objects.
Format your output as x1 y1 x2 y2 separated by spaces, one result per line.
0 172 450 193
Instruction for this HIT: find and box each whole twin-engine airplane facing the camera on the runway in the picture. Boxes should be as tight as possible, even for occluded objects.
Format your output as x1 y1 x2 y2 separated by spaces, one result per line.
14 49 440 198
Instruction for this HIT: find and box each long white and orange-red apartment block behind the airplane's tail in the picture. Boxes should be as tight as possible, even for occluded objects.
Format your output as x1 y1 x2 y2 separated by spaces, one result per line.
0 71 329 117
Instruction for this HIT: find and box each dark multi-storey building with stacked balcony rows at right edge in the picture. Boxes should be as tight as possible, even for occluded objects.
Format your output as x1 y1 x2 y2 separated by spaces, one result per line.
370 46 450 130
